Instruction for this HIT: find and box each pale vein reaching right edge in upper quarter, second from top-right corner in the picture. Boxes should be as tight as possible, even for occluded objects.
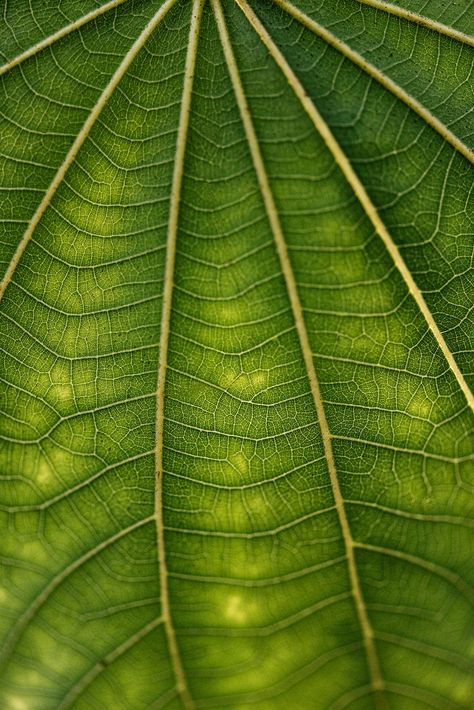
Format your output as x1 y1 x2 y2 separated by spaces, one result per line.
274 0 474 163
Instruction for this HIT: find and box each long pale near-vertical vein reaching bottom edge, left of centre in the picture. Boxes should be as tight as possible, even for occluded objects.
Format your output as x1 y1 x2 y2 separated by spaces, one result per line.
155 0 204 710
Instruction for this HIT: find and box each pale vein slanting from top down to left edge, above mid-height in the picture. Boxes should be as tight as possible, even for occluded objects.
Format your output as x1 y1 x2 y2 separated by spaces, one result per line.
0 0 181 300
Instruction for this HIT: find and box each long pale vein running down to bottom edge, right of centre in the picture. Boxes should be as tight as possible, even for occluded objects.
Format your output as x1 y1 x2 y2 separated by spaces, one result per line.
215 0 384 704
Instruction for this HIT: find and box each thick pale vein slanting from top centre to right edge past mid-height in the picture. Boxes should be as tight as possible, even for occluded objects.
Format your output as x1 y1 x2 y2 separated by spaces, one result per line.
236 0 474 418
